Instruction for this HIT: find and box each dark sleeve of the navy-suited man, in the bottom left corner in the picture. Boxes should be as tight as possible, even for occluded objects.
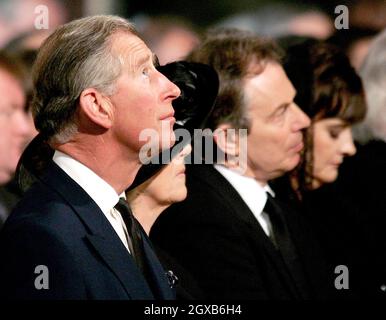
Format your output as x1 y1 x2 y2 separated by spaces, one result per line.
0 223 86 299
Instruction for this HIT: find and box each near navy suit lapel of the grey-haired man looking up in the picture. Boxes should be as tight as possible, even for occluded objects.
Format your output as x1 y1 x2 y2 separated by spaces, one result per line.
42 162 154 299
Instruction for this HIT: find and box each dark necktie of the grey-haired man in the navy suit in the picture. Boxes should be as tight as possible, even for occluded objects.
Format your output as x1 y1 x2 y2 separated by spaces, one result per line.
114 198 146 274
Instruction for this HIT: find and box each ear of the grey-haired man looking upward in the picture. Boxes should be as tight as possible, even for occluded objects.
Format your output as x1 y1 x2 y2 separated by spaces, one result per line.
79 88 113 129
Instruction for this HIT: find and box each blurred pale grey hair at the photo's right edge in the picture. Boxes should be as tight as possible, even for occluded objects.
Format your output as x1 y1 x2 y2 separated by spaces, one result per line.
354 29 386 143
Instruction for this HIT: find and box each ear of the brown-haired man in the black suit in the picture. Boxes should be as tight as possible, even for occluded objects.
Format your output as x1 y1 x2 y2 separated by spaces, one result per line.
213 123 240 157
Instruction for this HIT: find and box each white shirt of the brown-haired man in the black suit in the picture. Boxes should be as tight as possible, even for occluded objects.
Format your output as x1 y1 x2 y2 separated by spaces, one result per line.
214 164 275 236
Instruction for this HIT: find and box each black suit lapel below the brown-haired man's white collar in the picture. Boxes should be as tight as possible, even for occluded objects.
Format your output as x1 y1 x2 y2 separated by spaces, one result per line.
193 165 299 297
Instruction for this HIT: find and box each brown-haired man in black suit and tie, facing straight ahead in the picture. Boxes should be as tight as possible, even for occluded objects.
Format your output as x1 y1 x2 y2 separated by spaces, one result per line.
151 31 333 300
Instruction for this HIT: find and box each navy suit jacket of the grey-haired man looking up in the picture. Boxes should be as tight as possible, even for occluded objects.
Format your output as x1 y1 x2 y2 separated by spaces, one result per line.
0 163 175 299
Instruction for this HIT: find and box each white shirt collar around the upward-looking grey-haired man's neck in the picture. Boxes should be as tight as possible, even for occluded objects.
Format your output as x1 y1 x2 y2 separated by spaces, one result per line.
53 150 126 214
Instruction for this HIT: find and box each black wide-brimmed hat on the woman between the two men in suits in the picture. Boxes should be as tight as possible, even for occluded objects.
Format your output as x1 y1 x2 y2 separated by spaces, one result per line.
128 61 219 190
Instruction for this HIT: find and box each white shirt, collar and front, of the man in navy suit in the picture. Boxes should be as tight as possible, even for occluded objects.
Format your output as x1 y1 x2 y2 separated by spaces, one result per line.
53 151 130 252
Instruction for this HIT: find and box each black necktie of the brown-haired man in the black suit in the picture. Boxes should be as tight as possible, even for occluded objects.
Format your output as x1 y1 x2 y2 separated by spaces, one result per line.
263 193 309 298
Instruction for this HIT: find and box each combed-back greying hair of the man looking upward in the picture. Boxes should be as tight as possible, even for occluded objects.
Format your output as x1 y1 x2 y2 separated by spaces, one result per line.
31 15 138 143
